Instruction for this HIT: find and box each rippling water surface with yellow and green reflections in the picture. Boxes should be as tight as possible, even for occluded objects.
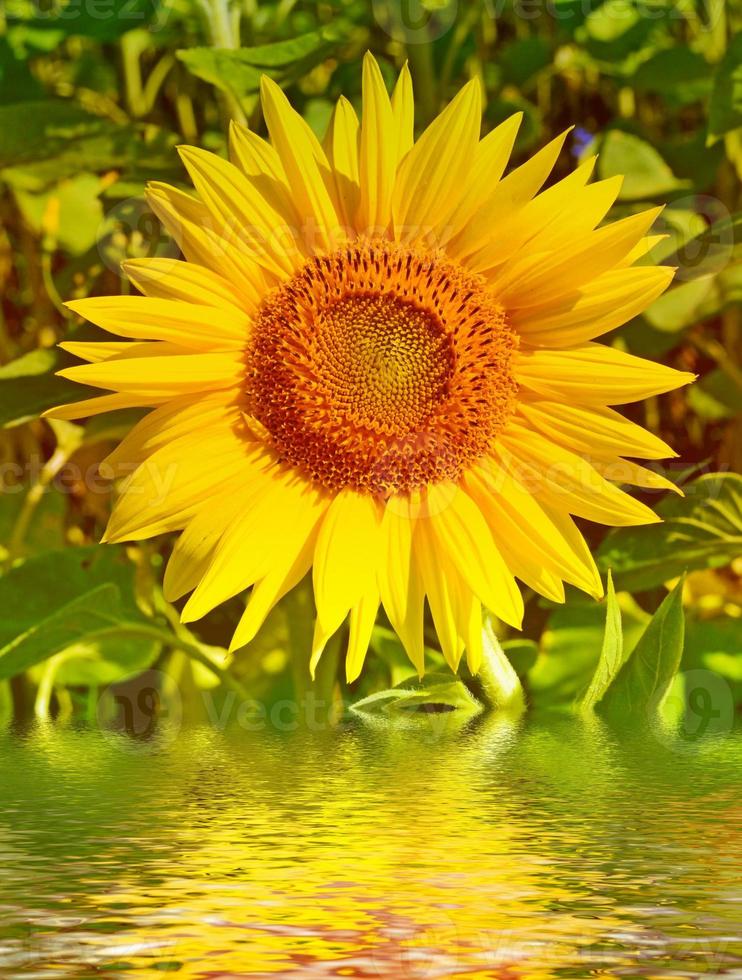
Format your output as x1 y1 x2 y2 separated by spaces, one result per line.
0 719 742 980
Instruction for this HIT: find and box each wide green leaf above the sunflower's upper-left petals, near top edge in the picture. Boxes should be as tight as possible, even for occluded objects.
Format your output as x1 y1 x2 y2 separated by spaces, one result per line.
177 26 342 98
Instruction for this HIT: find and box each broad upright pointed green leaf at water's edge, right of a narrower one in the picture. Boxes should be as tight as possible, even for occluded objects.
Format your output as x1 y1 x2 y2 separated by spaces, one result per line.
598 579 685 721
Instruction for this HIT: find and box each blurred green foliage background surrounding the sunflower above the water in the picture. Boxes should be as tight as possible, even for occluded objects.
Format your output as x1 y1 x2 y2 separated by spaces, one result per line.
0 0 742 730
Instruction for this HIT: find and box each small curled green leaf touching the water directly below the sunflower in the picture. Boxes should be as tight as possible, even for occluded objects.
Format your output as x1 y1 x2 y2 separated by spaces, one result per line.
350 674 482 725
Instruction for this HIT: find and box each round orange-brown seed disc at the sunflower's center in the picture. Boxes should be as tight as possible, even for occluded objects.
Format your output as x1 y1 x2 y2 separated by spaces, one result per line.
246 239 517 494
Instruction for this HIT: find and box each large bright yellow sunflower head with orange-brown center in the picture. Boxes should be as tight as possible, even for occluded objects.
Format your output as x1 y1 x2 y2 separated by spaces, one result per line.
51 55 692 681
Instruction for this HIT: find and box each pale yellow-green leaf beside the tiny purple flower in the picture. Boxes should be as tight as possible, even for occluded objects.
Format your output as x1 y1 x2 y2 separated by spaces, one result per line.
598 129 691 201
